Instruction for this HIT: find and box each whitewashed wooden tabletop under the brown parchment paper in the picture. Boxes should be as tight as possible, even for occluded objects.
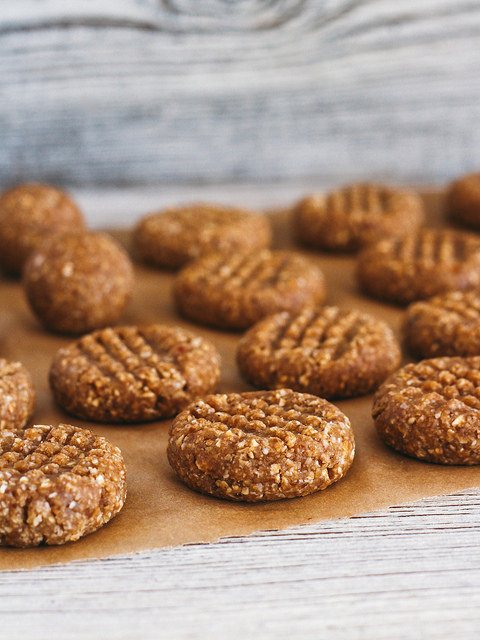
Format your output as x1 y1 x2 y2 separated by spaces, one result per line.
0 183 480 640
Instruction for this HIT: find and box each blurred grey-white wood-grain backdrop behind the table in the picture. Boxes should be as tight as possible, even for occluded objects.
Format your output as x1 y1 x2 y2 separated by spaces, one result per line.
0 0 480 186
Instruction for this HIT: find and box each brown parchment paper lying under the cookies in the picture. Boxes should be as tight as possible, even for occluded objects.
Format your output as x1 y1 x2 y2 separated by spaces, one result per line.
0 192 480 570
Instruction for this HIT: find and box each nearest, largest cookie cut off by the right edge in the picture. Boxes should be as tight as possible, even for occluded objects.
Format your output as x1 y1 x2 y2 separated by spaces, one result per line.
372 356 480 464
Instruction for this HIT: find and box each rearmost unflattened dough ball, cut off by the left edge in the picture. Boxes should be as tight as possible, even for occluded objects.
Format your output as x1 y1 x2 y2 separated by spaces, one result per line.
0 184 85 275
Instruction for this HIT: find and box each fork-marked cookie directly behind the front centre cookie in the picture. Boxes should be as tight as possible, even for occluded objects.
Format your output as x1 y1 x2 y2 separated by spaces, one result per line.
237 306 401 398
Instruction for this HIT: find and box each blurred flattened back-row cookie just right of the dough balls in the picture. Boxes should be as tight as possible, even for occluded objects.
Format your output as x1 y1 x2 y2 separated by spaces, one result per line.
133 204 272 269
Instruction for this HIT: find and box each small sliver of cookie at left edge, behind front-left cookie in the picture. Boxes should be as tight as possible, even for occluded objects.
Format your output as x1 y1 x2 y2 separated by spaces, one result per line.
0 358 35 431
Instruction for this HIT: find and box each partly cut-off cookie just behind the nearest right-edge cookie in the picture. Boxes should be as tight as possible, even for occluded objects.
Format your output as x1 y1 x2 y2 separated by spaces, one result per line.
404 291 480 358
